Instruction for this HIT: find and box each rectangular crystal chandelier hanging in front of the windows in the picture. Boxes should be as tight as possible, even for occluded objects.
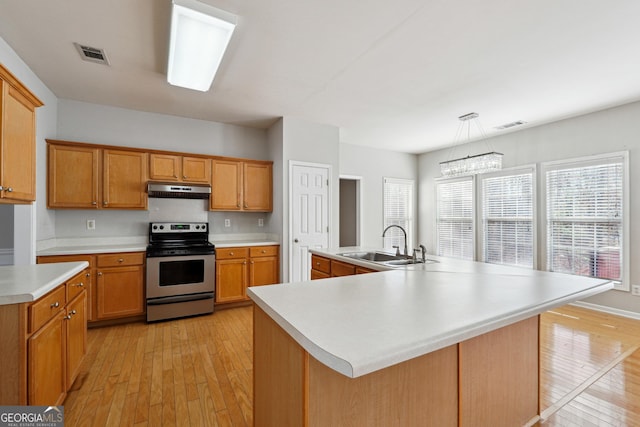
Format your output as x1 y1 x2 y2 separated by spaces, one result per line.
440 113 502 177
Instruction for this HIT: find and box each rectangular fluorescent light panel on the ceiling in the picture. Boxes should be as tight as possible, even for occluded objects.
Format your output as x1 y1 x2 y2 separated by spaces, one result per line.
167 0 237 92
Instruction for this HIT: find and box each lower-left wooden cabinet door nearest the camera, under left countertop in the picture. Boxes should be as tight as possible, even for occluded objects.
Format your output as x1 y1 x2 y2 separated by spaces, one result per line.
27 311 66 406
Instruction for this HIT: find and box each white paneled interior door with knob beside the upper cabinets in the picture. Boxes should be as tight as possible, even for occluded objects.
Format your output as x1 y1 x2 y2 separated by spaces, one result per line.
289 163 330 282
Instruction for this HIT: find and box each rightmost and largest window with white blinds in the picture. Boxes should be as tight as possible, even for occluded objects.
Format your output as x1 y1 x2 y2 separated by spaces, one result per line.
545 154 628 289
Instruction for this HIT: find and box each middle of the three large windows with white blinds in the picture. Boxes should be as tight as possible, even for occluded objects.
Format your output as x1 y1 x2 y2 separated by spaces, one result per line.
481 168 535 268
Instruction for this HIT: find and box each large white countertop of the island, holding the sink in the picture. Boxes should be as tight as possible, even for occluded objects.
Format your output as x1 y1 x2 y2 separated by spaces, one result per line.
247 249 613 377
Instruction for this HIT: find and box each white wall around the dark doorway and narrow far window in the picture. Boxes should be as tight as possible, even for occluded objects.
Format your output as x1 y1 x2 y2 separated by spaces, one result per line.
340 143 421 248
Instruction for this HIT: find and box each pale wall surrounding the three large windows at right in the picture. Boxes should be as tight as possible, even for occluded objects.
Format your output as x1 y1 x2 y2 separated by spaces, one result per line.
418 102 640 313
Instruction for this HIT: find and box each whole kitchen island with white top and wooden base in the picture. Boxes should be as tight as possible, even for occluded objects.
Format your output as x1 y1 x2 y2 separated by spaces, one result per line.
248 250 613 426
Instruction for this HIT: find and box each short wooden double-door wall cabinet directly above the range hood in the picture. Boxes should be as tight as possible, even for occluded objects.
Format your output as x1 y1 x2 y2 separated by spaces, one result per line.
149 153 211 183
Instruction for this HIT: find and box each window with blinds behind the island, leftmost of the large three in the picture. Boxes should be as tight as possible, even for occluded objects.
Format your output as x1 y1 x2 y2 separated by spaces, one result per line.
436 177 474 260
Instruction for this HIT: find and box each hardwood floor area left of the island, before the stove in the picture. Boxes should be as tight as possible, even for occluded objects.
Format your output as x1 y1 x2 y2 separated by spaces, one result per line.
64 307 253 426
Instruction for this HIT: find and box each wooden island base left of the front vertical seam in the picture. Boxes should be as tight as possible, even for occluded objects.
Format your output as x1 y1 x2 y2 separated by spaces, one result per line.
254 307 458 427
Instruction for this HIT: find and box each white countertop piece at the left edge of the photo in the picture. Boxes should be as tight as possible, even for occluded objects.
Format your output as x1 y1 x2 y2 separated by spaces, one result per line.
0 261 89 305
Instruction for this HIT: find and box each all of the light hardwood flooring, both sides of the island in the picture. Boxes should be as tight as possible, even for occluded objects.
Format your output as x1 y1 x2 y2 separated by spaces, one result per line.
65 306 640 427
